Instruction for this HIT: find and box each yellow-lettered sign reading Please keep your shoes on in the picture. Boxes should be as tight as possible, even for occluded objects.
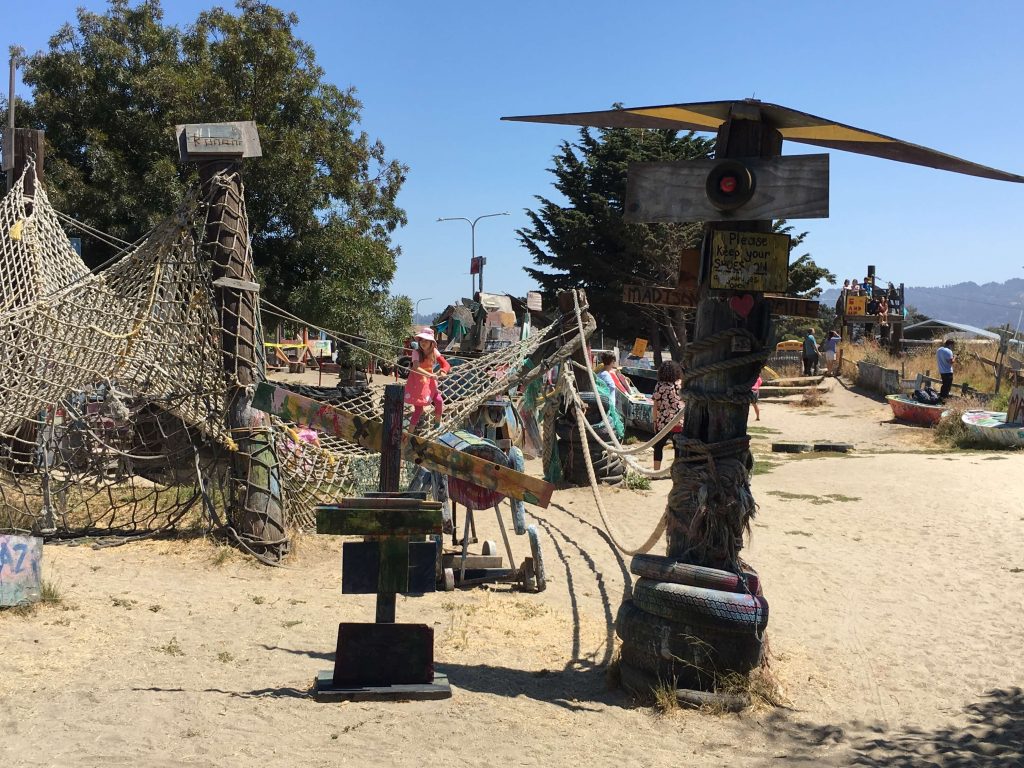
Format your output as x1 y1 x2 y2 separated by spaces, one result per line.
711 230 790 293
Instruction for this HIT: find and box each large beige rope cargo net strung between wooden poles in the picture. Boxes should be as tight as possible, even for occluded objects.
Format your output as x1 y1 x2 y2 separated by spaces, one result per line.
0 164 573 546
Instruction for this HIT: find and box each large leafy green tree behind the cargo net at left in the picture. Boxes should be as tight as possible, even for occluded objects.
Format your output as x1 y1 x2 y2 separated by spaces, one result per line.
19 0 411 352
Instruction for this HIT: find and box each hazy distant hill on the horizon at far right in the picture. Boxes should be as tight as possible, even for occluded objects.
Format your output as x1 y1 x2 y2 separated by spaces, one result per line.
821 278 1024 328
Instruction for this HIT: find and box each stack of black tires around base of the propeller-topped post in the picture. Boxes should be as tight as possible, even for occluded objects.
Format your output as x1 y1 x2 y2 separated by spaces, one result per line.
615 555 768 710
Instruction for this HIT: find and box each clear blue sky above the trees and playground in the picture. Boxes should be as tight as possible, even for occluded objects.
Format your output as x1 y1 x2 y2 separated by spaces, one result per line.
6 0 1024 311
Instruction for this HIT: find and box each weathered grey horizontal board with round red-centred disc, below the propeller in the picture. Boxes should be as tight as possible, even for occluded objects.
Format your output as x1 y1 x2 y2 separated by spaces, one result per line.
624 155 828 223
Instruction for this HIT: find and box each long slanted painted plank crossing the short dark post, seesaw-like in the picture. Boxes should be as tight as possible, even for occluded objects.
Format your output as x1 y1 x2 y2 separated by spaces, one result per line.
252 383 554 507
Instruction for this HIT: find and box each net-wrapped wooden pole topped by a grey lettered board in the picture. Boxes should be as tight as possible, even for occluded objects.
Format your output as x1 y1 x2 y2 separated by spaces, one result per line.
199 159 288 560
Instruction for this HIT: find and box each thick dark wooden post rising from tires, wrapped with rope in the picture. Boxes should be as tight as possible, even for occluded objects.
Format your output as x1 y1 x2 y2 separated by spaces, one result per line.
668 103 782 569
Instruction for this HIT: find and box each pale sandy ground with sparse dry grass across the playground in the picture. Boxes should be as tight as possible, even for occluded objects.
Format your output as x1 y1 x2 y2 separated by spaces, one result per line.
0 377 1024 768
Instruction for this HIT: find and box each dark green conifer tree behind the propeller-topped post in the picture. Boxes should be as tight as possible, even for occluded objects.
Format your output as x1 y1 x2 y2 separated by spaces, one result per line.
517 121 714 354
